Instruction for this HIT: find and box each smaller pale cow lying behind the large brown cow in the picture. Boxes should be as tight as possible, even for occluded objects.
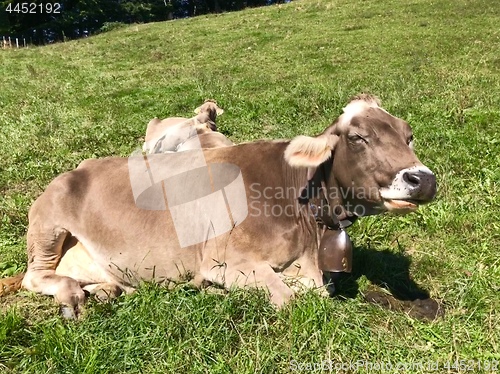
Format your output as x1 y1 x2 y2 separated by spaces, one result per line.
142 100 233 154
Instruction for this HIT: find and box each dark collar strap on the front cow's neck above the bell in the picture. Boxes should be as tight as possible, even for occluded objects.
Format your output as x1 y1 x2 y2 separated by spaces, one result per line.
298 161 357 230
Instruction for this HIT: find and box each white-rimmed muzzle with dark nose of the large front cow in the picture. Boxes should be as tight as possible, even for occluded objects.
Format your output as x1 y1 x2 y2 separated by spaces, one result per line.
380 166 437 213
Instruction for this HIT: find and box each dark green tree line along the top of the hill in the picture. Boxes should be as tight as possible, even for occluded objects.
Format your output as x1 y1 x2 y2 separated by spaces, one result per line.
0 0 287 44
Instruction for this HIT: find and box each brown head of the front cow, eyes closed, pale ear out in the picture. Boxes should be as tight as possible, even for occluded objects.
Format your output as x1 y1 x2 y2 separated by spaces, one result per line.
285 95 436 215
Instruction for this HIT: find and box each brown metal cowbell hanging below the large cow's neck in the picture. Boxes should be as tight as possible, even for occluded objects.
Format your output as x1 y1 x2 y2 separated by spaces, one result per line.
318 229 353 273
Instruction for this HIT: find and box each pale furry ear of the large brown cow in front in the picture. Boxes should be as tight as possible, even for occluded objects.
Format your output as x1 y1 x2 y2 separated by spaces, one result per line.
285 134 339 168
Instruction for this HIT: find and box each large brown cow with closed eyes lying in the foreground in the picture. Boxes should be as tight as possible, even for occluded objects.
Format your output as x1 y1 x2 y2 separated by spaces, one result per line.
0 95 436 315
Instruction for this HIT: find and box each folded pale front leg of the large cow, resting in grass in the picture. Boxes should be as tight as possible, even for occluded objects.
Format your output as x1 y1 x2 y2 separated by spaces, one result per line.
202 259 294 307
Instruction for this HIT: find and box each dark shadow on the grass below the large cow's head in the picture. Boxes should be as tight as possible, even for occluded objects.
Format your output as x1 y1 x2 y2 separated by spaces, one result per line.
334 247 444 320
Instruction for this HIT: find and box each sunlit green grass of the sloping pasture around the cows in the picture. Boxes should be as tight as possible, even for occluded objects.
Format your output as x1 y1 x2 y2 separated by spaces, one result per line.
0 0 500 373
